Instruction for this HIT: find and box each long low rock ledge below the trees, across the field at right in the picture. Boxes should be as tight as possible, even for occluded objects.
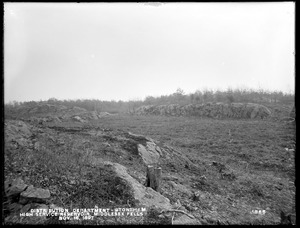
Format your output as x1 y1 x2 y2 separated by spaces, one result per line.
134 103 271 119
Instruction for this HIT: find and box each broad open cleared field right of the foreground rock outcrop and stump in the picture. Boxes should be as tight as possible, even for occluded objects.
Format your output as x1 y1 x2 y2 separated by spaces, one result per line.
85 115 295 224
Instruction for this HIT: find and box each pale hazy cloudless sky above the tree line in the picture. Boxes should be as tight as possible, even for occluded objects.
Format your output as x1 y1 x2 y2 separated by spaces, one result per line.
4 2 295 102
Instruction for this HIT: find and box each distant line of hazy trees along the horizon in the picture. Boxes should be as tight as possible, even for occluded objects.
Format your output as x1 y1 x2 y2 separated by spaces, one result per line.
5 88 295 113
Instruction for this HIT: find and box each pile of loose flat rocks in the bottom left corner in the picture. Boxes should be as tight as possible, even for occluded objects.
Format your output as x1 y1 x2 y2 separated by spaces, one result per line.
4 178 56 224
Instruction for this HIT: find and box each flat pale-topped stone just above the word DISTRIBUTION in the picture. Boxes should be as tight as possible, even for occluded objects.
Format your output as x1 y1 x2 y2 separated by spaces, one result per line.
19 185 50 204
